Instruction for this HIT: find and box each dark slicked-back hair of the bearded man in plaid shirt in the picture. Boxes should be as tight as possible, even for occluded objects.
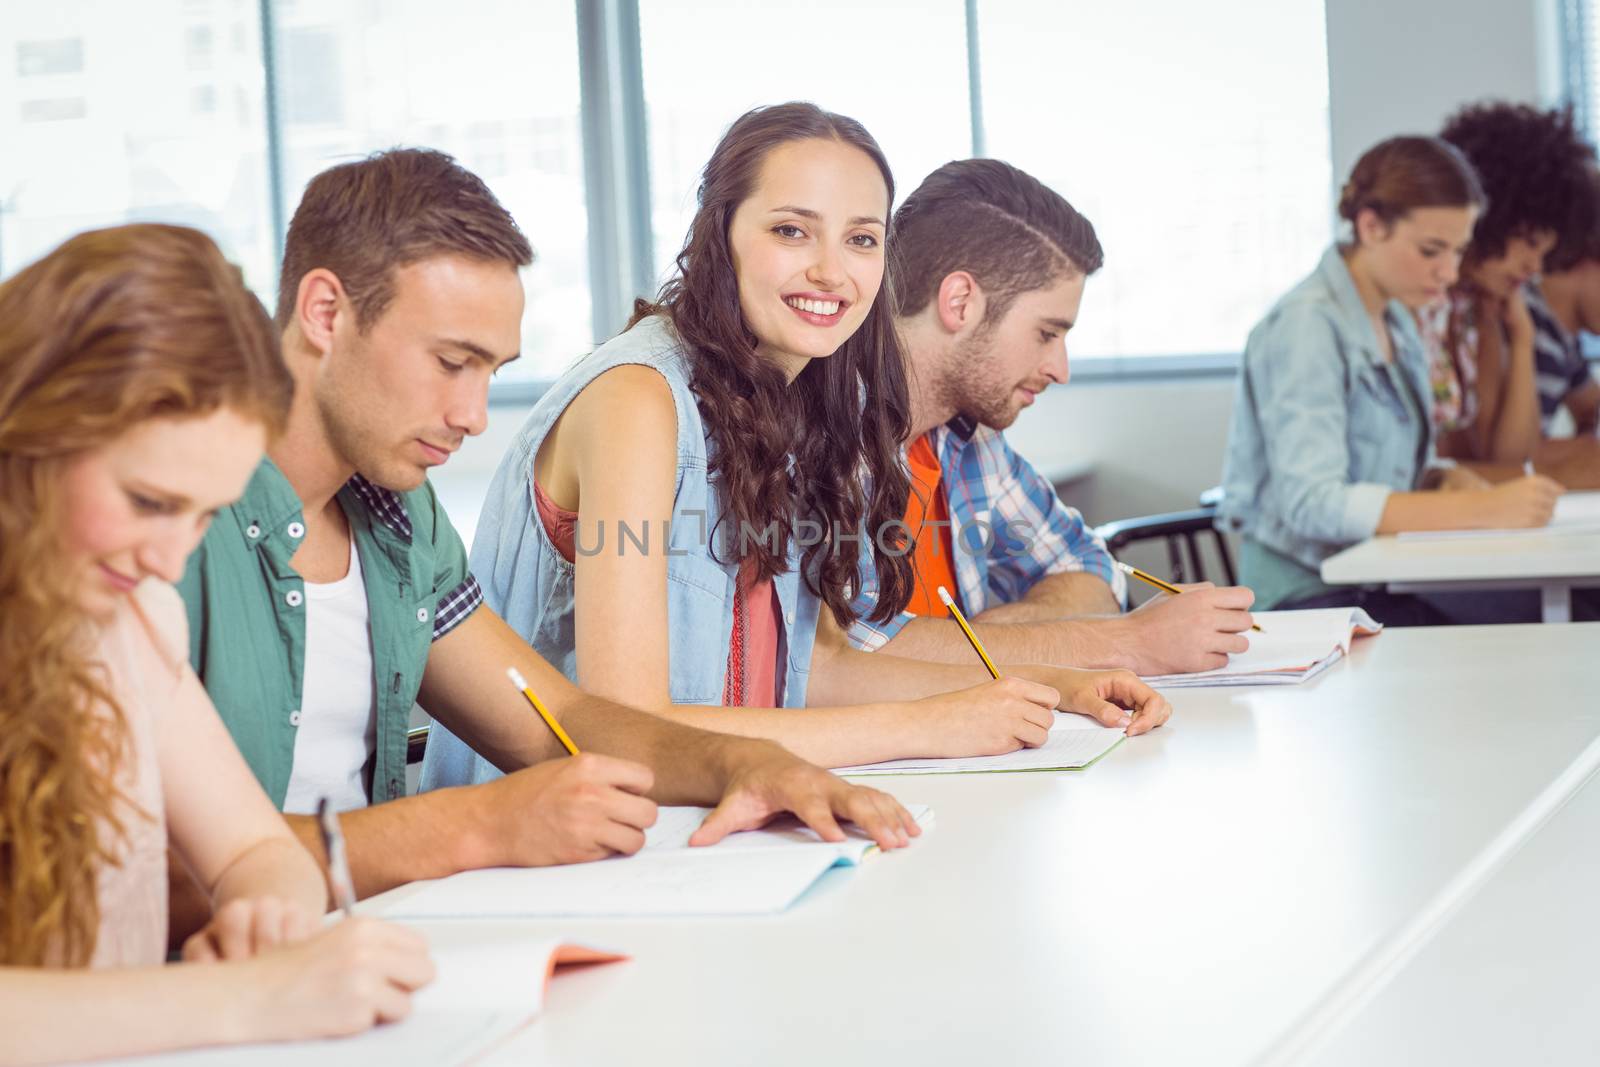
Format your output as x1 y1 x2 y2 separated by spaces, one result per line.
890 160 1106 322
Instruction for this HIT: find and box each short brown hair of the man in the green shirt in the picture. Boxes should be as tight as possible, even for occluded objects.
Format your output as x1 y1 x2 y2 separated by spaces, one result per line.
277 149 533 330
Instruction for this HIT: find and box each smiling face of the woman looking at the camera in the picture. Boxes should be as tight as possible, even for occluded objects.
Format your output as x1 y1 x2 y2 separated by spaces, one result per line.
728 139 890 379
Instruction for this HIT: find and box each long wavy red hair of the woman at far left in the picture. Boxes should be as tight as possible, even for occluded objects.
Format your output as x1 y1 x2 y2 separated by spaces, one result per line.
0 226 293 965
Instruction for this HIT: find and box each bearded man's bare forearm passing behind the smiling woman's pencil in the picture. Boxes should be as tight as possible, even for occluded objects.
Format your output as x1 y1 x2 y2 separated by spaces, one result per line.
878 616 1133 669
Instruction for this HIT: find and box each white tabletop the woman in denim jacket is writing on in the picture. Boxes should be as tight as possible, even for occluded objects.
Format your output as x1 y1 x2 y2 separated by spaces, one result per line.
1322 533 1600 585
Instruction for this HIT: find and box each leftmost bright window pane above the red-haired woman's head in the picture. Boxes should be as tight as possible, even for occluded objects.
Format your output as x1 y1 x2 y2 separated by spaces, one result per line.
0 0 275 294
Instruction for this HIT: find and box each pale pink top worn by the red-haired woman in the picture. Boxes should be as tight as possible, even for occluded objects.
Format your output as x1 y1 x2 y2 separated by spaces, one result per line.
90 579 189 968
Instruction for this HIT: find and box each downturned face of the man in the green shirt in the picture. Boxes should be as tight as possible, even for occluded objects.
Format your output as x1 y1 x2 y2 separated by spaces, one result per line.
312 256 523 493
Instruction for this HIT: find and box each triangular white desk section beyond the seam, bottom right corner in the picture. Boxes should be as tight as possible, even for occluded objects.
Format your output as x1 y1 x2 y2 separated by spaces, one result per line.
1317 764 1600 1067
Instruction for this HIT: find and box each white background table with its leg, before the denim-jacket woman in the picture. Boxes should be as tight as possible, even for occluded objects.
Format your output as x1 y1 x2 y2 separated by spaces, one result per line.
1322 533 1600 622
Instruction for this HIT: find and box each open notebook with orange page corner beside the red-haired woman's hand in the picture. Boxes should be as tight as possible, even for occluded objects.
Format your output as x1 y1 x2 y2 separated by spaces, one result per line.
102 923 626 1067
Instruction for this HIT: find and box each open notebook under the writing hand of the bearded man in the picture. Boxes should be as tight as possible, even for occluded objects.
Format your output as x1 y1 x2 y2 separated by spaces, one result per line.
1146 608 1384 689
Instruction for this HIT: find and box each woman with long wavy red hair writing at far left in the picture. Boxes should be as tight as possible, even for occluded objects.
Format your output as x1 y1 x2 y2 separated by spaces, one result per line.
0 226 432 1064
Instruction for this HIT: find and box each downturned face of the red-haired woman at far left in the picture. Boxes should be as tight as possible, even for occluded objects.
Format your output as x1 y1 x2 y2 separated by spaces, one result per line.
61 408 267 617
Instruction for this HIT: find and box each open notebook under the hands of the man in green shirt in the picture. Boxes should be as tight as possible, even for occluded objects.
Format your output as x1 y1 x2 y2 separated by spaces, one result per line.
384 805 933 920
